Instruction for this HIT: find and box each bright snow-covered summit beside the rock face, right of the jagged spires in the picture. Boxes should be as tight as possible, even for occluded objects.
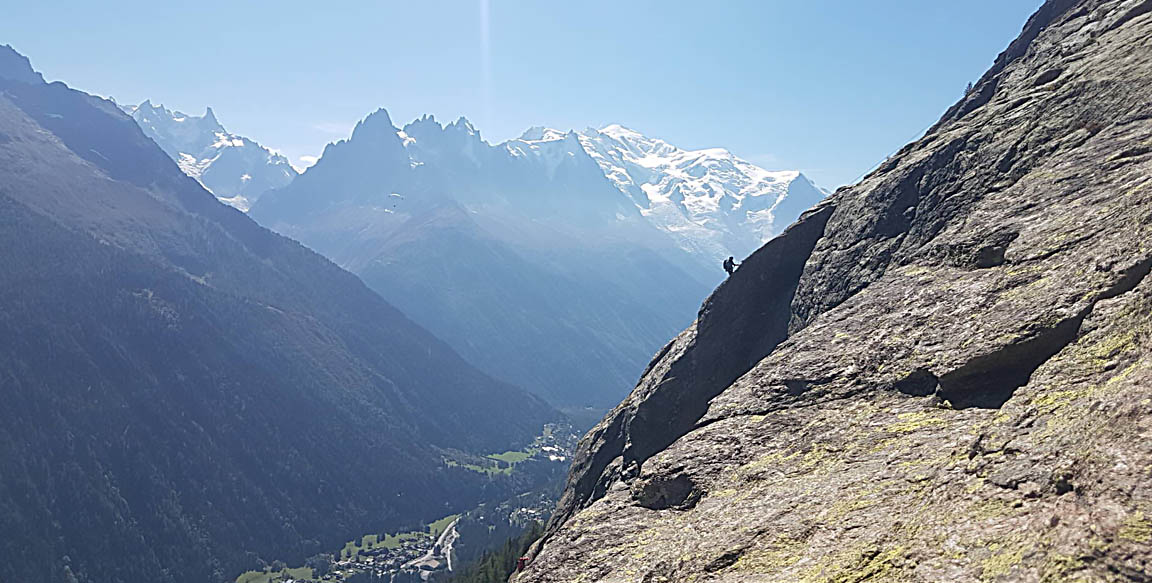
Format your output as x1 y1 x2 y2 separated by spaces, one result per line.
507 124 826 260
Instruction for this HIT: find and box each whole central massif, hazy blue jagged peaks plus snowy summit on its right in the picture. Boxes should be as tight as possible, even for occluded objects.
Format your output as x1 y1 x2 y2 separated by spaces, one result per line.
251 109 821 408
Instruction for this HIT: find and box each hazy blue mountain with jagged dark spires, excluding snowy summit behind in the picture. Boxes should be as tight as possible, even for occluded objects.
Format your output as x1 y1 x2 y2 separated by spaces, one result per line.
251 111 718 409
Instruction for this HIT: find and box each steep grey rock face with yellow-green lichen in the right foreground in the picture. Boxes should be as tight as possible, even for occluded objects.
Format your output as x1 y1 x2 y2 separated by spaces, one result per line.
515 0 1152 583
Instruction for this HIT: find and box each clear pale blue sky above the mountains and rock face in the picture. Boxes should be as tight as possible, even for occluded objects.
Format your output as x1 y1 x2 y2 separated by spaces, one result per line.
0 0 1041 187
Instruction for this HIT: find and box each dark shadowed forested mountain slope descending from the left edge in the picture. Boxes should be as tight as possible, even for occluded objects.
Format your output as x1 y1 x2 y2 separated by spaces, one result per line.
0 47 556 583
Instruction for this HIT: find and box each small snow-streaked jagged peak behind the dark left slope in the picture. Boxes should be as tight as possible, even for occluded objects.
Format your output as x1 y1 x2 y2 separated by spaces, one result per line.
124 101 296 211
